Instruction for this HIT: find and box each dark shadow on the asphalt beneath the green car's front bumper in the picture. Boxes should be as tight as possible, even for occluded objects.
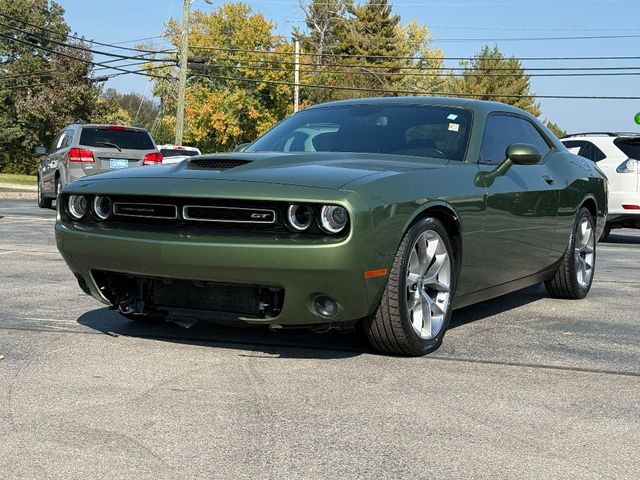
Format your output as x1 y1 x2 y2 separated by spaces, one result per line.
78 308 374 360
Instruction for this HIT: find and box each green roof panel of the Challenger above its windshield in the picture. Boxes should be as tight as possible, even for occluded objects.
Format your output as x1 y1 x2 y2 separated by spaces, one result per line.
308 96 531 116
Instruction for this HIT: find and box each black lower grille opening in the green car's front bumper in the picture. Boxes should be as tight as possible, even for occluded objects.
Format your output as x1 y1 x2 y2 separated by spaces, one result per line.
92 270 284 320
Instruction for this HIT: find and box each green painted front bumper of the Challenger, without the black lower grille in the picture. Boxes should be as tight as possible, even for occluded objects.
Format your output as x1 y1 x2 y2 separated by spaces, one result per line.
55 222 391 325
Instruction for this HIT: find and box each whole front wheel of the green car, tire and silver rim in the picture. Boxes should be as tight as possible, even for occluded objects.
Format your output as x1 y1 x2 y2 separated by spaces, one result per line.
364 217 456 356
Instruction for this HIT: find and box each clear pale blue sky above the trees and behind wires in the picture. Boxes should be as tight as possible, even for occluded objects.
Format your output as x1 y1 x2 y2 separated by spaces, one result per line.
58 0 640 132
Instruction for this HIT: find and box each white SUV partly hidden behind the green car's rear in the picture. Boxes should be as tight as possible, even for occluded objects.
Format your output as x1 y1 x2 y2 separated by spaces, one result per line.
561 132 640 240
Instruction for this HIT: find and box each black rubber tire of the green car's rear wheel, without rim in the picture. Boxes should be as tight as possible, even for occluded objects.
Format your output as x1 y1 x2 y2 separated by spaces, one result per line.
544 207 596 300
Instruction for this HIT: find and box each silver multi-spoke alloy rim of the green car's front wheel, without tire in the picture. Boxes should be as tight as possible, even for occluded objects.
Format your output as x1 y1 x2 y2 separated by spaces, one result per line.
406 230 451 340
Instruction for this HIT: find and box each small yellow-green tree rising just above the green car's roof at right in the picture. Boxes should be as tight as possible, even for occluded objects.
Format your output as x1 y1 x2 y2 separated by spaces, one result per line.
449 45 540 116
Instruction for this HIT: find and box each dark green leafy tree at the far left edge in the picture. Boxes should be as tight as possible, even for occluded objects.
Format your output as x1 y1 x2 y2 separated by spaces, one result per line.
0 0 99 173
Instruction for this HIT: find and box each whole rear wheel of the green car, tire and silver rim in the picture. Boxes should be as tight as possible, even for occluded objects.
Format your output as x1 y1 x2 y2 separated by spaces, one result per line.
545 208 596 300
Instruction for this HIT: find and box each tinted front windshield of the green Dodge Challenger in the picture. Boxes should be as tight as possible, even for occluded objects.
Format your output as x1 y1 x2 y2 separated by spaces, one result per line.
245 105 471 161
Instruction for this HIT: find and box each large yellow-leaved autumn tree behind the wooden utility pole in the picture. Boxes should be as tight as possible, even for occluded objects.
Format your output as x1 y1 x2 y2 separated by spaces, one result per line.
153 3 293 152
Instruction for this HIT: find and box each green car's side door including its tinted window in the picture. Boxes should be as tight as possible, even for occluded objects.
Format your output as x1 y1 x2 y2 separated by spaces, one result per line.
479 114 559 286
